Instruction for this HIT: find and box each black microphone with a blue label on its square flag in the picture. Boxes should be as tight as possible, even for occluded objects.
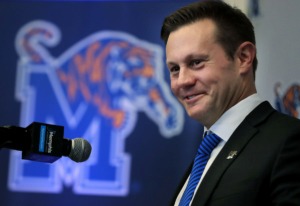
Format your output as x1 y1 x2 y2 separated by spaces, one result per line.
0 122 92 163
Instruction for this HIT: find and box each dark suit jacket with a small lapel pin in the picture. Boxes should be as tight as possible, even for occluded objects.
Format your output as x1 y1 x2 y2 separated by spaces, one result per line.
175 102 300 206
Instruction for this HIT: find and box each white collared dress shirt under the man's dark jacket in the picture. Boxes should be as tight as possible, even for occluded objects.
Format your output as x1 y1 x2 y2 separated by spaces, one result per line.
175 93 262 206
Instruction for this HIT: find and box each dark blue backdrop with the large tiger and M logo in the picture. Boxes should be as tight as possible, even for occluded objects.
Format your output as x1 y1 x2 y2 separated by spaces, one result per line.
0 1 202 206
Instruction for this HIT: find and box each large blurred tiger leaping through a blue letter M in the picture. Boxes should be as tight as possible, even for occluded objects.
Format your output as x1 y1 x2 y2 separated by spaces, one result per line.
8 21 184 196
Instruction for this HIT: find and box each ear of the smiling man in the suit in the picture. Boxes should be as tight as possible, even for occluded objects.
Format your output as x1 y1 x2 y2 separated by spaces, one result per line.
236 41 256 74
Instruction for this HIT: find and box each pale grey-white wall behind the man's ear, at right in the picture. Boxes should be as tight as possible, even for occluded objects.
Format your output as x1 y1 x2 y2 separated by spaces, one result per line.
252 0 300 104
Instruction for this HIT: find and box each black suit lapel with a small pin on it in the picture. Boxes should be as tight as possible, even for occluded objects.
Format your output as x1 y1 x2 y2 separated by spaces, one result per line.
192 102 274 206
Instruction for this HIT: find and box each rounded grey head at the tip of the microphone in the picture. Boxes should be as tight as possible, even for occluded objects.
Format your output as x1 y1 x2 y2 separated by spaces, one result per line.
69 138 92 162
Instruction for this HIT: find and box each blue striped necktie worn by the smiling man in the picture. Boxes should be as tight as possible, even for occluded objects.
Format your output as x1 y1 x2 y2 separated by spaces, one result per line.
179 133 221 206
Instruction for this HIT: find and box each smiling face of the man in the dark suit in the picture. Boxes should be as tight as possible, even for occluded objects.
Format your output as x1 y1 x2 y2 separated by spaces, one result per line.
166 19 243 128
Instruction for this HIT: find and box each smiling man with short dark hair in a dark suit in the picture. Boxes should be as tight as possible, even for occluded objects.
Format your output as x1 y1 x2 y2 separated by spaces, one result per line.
161 1 300 206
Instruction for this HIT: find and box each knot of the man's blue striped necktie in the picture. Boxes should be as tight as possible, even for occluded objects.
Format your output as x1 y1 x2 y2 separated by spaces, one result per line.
198 133 222 155
